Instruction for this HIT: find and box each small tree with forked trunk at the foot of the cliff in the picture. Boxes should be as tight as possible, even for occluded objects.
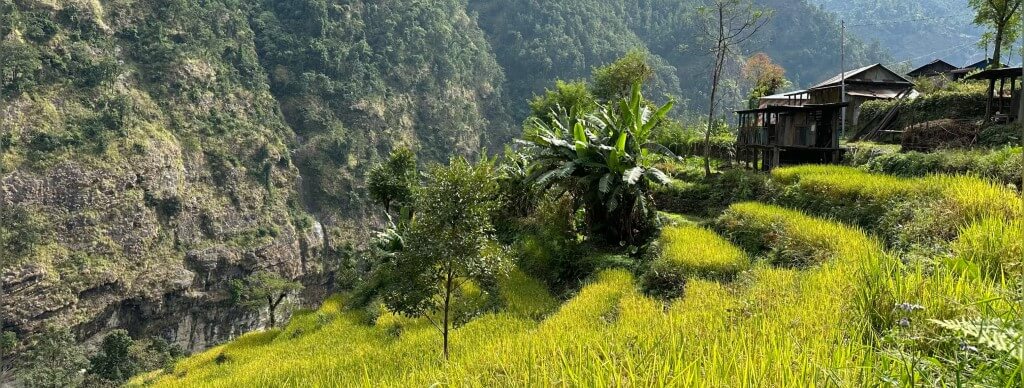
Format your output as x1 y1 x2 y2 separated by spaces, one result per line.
231 271 302 329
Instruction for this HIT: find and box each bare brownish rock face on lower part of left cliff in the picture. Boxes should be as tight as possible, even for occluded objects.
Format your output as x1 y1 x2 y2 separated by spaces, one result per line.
0 134 324 350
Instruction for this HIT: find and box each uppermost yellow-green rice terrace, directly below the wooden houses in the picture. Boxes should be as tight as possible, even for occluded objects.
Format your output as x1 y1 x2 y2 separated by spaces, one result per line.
772 166 1024 246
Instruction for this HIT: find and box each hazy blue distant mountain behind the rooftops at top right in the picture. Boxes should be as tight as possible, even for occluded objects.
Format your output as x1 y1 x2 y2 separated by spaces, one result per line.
813 0 985 68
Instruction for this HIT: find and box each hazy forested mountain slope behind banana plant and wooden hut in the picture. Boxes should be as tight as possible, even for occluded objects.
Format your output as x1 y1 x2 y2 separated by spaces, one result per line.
469 0 887 115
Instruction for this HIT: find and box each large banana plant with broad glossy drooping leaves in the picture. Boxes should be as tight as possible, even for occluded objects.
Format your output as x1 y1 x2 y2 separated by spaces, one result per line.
525 83 674 244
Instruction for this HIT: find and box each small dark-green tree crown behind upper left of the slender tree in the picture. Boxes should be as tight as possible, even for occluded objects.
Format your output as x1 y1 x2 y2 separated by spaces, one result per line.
367 147 416 214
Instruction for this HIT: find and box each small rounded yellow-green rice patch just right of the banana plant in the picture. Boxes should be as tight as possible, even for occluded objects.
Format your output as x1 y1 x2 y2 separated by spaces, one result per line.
643 226 750 297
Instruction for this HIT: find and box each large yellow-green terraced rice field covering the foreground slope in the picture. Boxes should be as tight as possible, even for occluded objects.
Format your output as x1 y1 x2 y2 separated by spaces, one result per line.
133 167 1024 387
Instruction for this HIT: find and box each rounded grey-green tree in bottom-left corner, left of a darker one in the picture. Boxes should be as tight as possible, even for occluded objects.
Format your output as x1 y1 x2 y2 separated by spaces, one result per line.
18 328 89 388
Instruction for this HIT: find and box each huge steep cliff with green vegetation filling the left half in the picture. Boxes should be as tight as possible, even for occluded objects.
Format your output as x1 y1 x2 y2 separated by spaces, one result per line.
0 0 509 349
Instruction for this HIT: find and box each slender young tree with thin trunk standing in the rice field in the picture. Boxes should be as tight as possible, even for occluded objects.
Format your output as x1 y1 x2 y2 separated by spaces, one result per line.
383 158 504 359
